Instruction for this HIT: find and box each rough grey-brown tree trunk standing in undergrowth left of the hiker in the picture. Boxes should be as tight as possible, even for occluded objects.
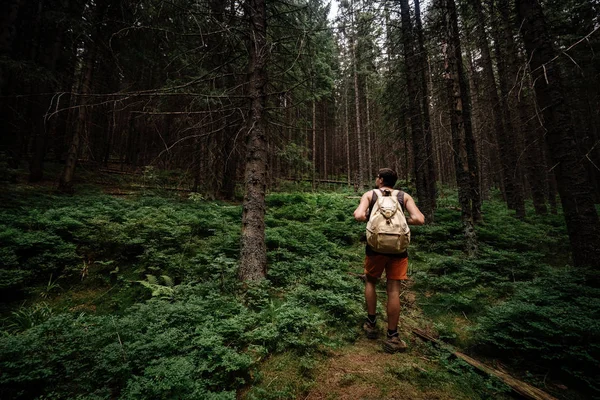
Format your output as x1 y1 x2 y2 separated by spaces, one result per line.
239 0 269 281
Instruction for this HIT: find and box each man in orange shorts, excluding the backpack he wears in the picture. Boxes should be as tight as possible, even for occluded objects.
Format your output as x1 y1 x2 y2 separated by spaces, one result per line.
354 168 425 353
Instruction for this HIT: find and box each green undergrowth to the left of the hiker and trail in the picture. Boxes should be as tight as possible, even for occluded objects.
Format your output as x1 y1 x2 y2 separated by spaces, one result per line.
0 188 362 399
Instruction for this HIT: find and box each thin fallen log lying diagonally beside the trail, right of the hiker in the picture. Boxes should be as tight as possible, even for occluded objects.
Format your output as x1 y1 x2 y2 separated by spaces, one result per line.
412 328 557 400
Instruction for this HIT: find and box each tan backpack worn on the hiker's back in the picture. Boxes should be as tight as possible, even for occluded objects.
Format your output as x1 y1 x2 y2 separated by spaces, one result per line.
367 189 410 254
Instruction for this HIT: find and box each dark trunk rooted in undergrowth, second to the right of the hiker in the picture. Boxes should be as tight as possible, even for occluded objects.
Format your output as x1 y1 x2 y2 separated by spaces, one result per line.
445 0 478 257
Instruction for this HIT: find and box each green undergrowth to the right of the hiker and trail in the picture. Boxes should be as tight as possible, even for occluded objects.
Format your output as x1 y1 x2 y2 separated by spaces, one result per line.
413 189 600 398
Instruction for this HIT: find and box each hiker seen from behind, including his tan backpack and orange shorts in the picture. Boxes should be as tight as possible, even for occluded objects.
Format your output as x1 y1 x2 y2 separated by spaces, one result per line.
354 168 425 353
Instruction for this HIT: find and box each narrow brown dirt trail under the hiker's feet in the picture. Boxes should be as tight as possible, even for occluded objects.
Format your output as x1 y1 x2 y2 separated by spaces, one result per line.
305 286 470 400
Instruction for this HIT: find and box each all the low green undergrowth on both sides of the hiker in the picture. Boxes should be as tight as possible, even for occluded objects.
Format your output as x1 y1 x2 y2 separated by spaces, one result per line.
0 186 600 399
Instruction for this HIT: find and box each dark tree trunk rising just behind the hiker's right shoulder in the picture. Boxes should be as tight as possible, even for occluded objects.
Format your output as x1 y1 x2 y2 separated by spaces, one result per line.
400 0 433 222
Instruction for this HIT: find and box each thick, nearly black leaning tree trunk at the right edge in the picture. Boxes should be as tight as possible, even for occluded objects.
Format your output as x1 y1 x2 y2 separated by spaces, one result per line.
515 0 600 268
